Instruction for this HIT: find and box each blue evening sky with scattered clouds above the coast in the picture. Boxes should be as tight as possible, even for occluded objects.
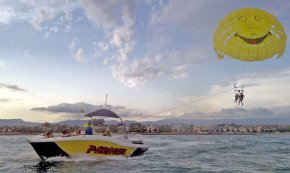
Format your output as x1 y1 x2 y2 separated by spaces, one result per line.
0 0 290 122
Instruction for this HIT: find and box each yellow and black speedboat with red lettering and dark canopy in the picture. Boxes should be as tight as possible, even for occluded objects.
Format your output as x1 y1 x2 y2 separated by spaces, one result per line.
28 104 149 159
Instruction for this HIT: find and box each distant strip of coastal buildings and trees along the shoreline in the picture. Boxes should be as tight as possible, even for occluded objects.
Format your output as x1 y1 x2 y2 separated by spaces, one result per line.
0 123 290 135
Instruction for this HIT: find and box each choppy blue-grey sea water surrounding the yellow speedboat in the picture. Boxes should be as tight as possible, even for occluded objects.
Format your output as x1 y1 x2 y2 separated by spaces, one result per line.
0 134 290 173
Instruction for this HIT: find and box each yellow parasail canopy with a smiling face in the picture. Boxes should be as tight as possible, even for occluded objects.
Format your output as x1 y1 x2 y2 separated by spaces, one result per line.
214 8 287 61
